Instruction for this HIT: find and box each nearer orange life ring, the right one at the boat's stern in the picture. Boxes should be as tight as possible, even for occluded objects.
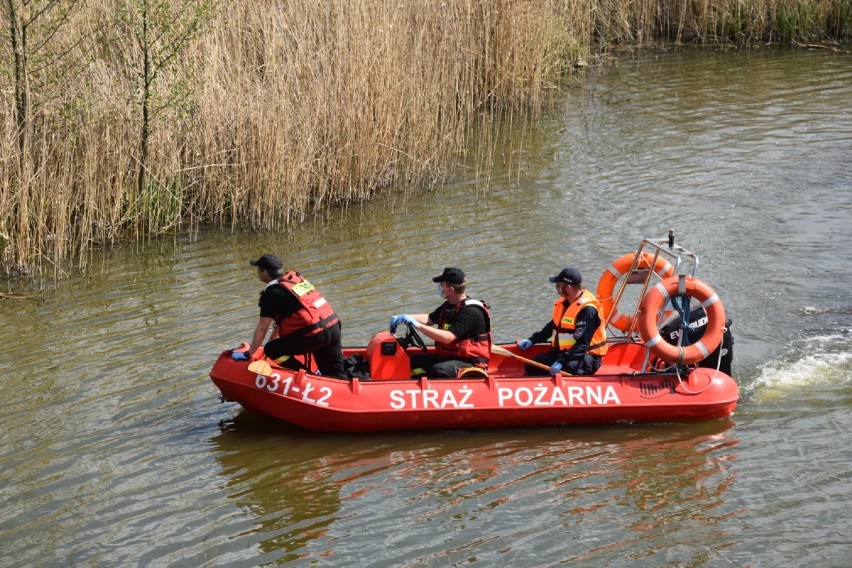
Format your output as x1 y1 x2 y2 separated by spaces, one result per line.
639 276 725 365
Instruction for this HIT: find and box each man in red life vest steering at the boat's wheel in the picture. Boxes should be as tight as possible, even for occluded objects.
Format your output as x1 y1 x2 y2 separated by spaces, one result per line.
390 267 491 378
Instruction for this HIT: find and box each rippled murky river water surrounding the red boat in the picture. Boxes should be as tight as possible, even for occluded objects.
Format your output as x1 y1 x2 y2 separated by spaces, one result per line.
0 50 852 567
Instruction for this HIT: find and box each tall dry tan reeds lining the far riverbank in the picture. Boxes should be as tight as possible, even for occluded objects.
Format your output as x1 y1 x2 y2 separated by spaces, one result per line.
0 0 852 279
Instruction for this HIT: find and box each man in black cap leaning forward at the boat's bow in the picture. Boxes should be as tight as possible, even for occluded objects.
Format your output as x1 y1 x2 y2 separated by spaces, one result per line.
231 254 347 379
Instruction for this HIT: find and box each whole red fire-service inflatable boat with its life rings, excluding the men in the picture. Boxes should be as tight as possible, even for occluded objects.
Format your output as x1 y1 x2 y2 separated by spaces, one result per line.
210 236 739 432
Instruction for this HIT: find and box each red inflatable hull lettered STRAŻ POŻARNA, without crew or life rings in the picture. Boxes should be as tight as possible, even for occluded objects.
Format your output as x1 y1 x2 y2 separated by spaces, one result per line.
210 346 739 432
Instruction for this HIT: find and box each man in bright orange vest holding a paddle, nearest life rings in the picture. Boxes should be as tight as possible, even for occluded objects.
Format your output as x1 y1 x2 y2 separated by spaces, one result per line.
518 268 607 375
